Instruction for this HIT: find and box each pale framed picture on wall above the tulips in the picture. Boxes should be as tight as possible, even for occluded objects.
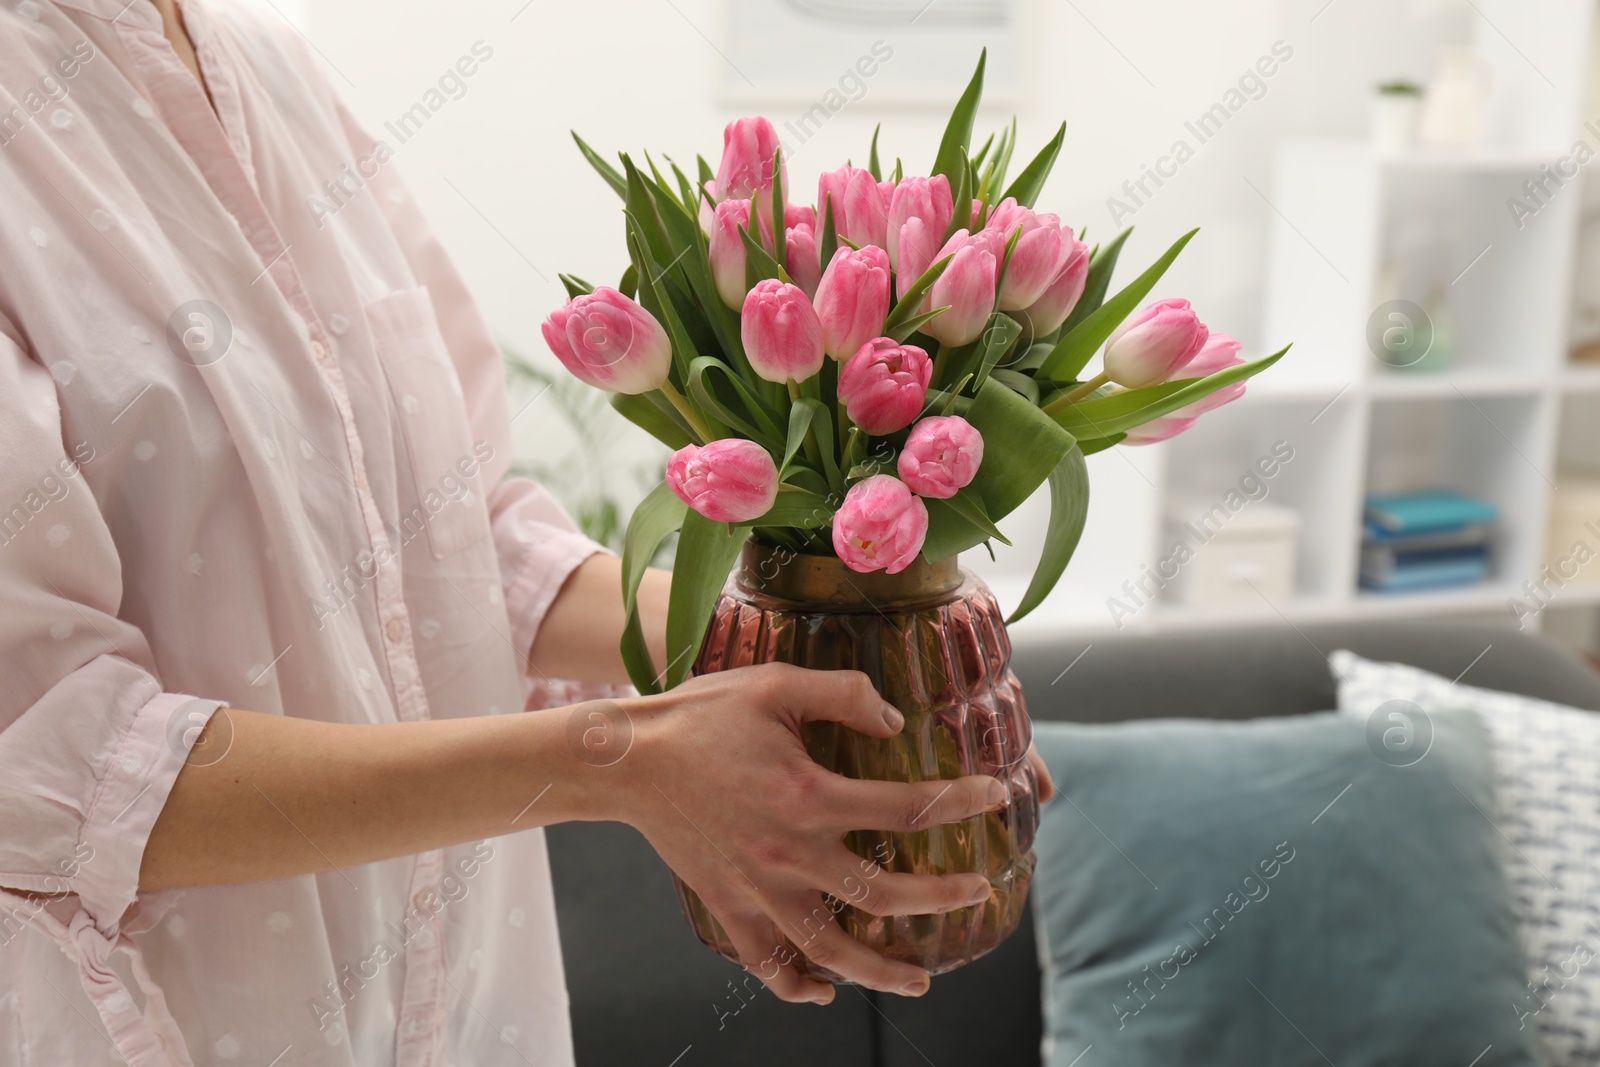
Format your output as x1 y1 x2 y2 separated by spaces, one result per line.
723 0 1021 103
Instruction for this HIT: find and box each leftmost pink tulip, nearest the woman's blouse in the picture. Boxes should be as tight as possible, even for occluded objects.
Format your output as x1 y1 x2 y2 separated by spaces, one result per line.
541 286 672 394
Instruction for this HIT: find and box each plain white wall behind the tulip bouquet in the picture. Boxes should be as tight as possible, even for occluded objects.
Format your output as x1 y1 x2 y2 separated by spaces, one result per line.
307 0 1477 550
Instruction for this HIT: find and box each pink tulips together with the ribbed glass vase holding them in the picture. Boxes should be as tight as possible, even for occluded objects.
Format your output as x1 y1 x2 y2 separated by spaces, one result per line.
544 58 1283 973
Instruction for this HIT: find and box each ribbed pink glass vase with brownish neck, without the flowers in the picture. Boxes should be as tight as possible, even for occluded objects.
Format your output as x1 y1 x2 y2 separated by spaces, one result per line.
674 541 1038 979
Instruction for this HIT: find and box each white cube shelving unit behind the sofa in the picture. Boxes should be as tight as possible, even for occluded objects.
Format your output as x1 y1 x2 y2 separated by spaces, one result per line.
978 0 1600 641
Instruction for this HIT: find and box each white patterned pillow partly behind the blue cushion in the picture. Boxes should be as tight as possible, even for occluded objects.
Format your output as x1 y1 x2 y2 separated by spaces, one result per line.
1330 649 1600 1067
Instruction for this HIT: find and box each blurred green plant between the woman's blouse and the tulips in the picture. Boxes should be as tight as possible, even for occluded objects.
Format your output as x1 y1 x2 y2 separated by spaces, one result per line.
501 344 670 557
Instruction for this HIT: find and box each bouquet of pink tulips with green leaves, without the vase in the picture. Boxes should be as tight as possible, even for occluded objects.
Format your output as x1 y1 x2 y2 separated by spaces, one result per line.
544 59 1286 691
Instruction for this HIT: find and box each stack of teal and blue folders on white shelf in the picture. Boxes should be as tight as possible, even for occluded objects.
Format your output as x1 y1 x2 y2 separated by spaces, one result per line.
1360 491 1499 592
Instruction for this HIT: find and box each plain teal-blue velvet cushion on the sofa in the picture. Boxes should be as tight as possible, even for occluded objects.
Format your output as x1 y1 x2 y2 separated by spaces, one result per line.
1034 713 1542 1067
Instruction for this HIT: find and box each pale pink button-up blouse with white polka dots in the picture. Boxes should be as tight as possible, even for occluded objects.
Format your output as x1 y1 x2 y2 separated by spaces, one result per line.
0 0 597 1067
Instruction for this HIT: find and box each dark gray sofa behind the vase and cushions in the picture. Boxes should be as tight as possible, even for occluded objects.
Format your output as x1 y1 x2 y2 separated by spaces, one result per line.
549 622 1600 1067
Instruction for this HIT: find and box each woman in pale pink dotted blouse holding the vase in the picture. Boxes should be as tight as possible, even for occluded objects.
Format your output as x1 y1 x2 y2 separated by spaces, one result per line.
0 0 1049 1067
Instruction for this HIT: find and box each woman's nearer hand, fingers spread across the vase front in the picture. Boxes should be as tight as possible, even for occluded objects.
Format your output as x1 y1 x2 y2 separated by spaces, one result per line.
595 664 1004 1003
